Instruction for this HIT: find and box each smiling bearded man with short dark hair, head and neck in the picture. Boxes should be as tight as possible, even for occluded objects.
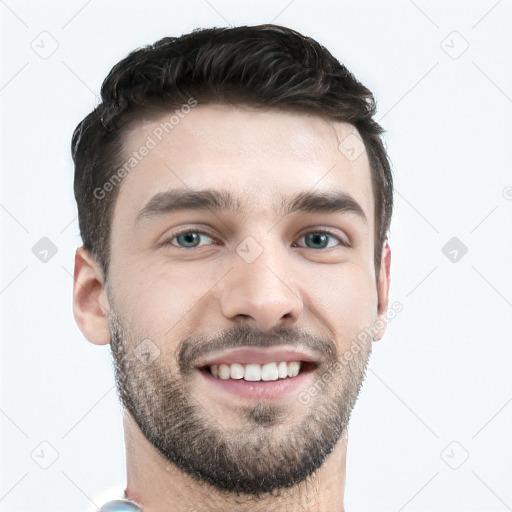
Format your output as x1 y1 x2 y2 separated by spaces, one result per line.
72 25 393 512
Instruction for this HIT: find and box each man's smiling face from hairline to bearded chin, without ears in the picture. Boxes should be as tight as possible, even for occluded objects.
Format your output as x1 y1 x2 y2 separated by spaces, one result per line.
107 105 388 494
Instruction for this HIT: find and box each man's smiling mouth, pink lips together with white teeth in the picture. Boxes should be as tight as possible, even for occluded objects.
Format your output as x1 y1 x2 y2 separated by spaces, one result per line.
196 348 319 400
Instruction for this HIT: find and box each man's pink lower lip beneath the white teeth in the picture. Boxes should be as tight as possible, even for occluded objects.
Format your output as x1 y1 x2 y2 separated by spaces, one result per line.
199 370 313 400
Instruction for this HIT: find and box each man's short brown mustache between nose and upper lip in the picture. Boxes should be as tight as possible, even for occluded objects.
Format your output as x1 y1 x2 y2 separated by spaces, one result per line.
176 323 338 373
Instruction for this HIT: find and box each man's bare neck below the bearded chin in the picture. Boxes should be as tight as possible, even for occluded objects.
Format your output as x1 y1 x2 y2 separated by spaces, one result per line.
124 412 348 512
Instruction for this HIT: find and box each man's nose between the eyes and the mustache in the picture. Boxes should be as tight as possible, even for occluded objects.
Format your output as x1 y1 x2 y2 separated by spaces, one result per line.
220 239 304 331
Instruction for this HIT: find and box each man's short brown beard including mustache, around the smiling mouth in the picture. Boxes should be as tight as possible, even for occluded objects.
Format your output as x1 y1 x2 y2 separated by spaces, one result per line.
109 301 371 498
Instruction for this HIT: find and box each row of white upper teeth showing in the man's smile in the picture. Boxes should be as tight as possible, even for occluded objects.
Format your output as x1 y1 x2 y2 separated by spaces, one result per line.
210 361 301 382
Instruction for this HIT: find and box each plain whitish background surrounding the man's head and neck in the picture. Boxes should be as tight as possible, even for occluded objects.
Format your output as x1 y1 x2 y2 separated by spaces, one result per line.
0 0 512 512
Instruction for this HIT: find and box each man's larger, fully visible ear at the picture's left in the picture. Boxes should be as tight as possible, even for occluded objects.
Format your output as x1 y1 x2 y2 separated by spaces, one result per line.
73 247 110 345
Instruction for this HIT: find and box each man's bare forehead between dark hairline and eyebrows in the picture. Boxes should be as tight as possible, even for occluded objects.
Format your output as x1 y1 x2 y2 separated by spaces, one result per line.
114 105 374 227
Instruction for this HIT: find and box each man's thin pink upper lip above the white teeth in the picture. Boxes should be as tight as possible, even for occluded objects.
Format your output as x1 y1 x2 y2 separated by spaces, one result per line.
196 347 317 368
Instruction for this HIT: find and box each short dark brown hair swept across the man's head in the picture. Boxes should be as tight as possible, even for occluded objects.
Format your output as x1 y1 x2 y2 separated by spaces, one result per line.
71 24 393 277
